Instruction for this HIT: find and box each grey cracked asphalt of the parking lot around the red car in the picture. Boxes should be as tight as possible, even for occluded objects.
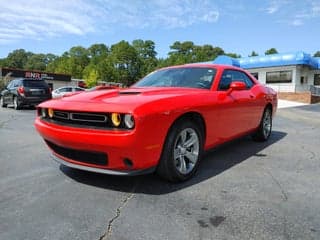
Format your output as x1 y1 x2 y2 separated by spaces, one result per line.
0 104 320 240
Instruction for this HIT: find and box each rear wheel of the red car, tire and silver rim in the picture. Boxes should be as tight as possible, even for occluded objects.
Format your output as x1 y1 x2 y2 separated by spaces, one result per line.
252 107 272 142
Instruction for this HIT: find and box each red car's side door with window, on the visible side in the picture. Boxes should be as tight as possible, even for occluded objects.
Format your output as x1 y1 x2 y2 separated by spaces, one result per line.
218 69 257 139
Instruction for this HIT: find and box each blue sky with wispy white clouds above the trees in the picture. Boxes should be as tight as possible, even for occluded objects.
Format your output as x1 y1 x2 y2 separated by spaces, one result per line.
0 0 320 58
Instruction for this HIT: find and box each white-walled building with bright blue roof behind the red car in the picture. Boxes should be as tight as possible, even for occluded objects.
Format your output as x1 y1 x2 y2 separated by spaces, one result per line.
213 51 320 92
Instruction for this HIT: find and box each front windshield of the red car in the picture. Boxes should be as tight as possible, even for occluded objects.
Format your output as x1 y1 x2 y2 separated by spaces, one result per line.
134 67 216 89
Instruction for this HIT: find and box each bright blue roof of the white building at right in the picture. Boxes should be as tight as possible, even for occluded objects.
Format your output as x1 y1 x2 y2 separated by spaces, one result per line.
213 51 320 69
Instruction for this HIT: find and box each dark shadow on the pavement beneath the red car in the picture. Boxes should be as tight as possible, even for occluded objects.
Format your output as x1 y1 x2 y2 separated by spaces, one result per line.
60 131 287 195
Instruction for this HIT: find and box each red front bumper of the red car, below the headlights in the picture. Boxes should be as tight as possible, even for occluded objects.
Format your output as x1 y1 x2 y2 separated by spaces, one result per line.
35 117 162 172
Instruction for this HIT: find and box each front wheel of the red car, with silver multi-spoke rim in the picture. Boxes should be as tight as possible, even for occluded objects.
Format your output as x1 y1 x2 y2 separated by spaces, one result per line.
157 120 203 182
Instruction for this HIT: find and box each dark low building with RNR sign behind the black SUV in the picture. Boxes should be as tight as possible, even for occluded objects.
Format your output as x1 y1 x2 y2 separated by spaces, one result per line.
0 68 72 89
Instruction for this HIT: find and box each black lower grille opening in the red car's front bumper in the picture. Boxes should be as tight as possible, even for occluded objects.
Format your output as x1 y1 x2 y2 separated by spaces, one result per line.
45 140 108 166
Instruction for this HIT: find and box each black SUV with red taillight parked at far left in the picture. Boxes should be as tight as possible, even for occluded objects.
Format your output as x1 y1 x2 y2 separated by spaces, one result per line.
0 78 52 109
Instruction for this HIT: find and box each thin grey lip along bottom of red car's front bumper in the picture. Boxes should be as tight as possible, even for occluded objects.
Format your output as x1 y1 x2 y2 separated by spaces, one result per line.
51 153 156 176
